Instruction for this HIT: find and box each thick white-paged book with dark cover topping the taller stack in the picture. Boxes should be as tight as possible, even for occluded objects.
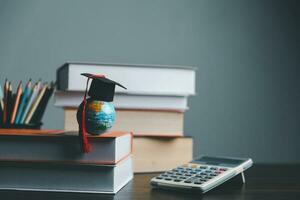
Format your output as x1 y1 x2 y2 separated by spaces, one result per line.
57 63 196 96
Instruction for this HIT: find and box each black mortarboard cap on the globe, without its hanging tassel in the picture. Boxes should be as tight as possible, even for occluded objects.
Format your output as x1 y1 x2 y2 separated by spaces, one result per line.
81 73 126 102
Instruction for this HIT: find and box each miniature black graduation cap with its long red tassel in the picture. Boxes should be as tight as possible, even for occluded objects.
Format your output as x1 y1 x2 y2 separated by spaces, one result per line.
79 73 127 153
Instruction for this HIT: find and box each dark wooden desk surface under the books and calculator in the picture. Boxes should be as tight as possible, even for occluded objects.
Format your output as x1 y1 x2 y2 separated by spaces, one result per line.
0 165 300 200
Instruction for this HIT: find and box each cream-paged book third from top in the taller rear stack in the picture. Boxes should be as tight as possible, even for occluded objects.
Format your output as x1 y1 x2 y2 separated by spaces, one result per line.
64 108 184 136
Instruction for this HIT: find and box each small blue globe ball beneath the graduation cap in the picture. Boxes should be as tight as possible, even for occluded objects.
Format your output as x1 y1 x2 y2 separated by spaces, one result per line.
77 99 116 135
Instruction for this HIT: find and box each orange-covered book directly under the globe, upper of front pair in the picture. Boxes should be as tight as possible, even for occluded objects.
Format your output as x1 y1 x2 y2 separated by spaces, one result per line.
0 129 132 165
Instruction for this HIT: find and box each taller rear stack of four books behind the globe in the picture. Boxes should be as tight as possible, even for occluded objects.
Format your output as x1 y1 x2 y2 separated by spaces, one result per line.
55 63 196 172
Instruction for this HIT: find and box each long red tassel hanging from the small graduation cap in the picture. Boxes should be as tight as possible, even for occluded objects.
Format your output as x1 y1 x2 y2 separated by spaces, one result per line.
79 78 92 153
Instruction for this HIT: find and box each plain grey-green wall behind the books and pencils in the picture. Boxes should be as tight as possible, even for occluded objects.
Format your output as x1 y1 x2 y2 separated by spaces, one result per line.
0 0 300 163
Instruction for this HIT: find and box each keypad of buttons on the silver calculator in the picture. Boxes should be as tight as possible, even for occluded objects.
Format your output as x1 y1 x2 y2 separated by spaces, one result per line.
155 164 228 185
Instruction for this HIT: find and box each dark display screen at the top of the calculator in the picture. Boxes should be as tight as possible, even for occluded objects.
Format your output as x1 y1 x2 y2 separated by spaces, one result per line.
193 156 245 167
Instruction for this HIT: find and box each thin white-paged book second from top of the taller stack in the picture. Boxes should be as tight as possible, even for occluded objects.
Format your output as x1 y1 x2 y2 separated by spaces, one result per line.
54 91 188 111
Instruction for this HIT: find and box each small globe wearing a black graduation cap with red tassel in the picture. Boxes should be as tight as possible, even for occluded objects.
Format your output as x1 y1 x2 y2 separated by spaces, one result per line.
77 73 126 153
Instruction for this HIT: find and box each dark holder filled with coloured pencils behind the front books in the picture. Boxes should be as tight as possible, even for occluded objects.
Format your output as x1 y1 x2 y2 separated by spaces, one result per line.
0 79 55 129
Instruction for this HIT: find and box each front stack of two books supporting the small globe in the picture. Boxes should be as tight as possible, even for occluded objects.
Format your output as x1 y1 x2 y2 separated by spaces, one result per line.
0 129 133 193
